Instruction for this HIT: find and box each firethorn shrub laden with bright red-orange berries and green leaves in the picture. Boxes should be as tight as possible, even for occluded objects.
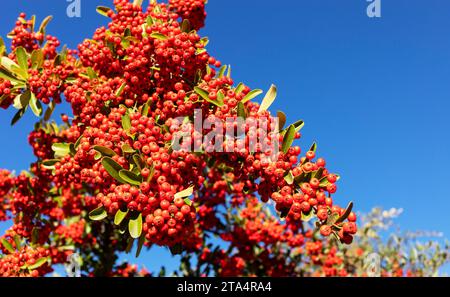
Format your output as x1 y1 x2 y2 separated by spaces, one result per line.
0 0 442 276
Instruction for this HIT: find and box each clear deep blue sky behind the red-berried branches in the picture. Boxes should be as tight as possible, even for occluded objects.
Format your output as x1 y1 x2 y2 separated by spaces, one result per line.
0 0 450 271
